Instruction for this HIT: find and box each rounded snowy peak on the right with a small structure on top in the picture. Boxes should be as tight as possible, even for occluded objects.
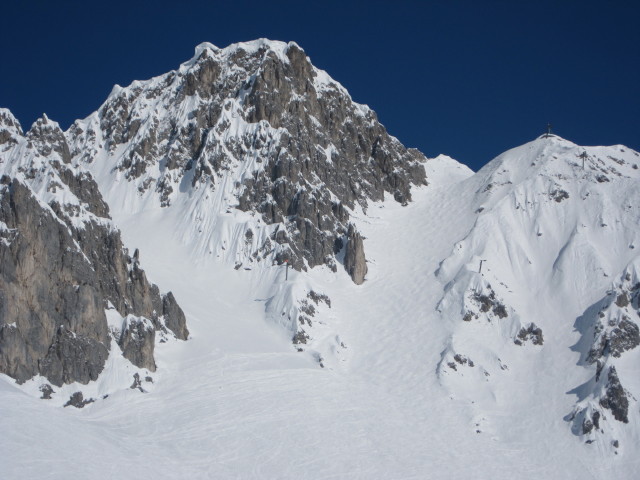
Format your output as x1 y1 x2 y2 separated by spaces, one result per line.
436 136 640 452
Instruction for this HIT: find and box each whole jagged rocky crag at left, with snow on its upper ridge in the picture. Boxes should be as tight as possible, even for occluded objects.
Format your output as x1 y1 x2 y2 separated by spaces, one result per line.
0 109 188 396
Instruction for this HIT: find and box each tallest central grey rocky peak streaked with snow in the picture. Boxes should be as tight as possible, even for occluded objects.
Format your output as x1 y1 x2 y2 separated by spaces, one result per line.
66 40 426 284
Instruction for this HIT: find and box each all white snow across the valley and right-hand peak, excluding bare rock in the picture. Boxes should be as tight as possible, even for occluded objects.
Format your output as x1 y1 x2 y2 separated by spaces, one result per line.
0 133 640 479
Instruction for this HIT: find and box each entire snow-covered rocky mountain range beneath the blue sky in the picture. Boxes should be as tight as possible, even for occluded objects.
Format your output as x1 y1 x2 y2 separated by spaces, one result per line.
0 40 640 479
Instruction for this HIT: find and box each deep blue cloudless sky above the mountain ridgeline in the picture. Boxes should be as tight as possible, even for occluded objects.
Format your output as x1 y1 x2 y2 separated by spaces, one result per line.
0 0 640 169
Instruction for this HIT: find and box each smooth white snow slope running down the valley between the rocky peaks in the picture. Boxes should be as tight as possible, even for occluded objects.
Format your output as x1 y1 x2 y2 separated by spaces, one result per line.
0 141 640 480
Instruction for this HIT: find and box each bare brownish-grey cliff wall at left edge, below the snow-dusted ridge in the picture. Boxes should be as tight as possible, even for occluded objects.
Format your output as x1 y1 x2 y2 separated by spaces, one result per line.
0 177 109 386
